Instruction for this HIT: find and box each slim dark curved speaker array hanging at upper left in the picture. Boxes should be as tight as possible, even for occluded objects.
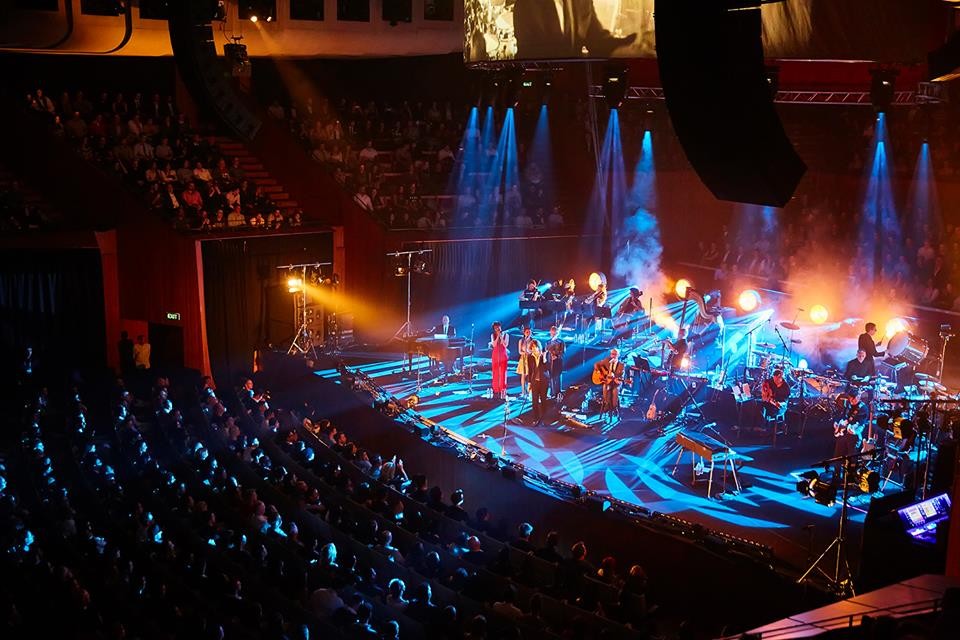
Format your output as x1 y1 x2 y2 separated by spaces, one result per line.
168 2 261 140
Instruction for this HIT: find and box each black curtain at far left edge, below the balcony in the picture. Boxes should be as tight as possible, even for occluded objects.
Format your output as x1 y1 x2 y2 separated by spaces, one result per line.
0 249 106 374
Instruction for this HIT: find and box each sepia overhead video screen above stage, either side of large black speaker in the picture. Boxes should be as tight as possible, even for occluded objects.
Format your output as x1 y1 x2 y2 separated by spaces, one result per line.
463 0 942 64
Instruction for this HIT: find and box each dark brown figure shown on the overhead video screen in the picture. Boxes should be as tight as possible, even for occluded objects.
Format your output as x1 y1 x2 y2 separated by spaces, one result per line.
513 0 637 59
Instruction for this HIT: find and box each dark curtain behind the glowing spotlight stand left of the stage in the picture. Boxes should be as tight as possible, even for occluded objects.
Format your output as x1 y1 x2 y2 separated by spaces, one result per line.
203 232 333 382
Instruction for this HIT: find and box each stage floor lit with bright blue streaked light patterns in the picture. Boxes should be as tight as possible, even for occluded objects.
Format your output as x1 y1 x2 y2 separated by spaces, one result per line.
316 349 899 573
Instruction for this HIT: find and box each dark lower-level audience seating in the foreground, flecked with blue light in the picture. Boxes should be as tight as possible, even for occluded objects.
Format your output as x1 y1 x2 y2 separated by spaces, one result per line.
0 362 655 638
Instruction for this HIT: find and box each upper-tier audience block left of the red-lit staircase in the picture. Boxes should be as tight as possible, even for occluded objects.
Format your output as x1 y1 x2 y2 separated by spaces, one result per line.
27 89 303 231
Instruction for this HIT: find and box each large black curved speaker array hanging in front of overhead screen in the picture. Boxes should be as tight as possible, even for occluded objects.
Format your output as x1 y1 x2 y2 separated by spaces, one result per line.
655 0 807 207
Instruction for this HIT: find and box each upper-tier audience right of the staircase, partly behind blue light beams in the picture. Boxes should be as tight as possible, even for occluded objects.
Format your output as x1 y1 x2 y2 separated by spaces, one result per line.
269 98 565 229
